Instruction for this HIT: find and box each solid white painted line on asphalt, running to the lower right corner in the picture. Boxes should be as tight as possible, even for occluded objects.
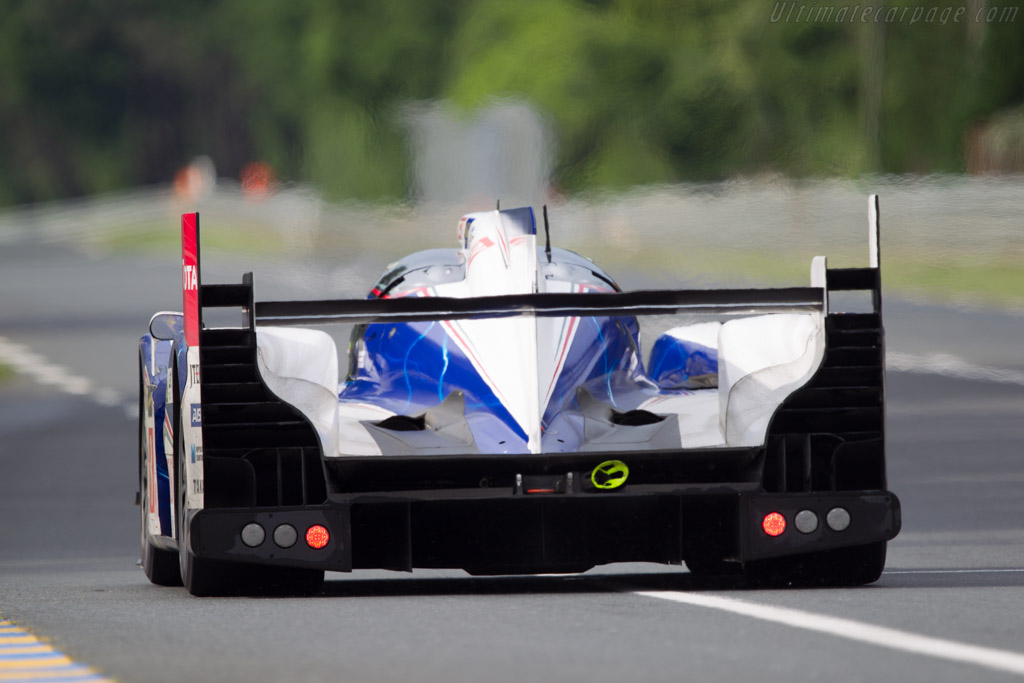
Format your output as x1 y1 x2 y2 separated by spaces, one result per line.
633 591 1024 676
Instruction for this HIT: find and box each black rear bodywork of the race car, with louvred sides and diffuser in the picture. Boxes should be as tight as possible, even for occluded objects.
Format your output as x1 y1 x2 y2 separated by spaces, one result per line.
190 267 900 580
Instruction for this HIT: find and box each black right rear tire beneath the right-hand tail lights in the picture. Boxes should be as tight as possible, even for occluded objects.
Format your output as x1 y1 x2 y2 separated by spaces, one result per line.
743 541 887 588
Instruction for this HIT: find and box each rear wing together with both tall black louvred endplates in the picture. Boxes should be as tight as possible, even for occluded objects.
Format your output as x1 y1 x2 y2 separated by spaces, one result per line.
182 196 885 507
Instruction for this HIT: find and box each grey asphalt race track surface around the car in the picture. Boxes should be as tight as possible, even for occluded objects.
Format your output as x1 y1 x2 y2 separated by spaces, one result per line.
0 246 1024 683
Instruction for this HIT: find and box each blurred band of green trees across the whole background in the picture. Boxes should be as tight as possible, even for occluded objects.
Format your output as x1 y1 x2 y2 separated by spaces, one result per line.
0 0 1024 205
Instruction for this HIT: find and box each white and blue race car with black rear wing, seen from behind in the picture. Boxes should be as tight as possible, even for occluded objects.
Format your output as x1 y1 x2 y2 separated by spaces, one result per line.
138 196 900 595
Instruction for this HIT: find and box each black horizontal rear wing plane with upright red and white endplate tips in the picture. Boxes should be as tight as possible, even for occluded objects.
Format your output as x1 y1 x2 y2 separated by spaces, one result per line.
181 195 882 331
